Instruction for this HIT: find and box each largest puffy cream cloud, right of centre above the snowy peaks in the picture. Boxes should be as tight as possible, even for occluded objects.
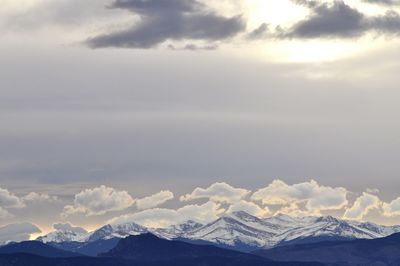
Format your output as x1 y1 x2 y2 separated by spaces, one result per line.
251 180 348 212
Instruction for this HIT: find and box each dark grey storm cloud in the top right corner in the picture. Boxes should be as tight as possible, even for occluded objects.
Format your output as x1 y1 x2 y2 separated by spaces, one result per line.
279 0 400 38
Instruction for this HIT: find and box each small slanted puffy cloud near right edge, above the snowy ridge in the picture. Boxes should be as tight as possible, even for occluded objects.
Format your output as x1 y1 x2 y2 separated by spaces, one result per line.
343 192 381 220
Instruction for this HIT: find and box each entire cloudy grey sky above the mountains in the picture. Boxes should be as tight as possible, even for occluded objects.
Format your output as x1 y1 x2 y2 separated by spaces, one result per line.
0 0 400 241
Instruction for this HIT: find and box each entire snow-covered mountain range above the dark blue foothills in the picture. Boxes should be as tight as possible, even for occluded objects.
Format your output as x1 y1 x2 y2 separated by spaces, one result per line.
38 211 400 251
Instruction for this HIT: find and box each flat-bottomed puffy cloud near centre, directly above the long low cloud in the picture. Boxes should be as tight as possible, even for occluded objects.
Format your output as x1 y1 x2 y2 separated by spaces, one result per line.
180 183 250 203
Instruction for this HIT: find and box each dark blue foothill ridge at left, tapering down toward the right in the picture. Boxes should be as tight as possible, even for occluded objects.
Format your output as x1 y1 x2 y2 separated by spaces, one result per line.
0 233 323 266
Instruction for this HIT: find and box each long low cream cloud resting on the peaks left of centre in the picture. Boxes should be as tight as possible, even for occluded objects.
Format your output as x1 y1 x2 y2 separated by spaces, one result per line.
109 201 225 228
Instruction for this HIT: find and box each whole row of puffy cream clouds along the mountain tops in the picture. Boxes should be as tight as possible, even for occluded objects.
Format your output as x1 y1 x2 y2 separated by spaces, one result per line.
5 179 400 230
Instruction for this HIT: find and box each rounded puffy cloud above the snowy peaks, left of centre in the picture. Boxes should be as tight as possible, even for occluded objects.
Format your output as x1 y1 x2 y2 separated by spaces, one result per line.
62 186 135 217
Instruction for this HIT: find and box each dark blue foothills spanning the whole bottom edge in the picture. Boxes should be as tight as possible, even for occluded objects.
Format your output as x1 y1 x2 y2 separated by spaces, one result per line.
0 228 400 266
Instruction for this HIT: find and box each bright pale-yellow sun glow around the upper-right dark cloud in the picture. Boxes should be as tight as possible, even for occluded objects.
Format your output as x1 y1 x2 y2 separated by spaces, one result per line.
233 0 396 63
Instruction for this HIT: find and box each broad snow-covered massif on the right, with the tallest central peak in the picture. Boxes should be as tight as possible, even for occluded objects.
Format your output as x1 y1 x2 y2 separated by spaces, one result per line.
184 211 400 250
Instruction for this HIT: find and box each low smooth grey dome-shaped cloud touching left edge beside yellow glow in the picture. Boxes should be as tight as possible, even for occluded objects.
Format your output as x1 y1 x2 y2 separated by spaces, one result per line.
0 223 41 244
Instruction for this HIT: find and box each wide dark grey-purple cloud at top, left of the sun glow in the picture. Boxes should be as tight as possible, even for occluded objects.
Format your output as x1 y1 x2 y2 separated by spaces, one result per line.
87 0 245 48
